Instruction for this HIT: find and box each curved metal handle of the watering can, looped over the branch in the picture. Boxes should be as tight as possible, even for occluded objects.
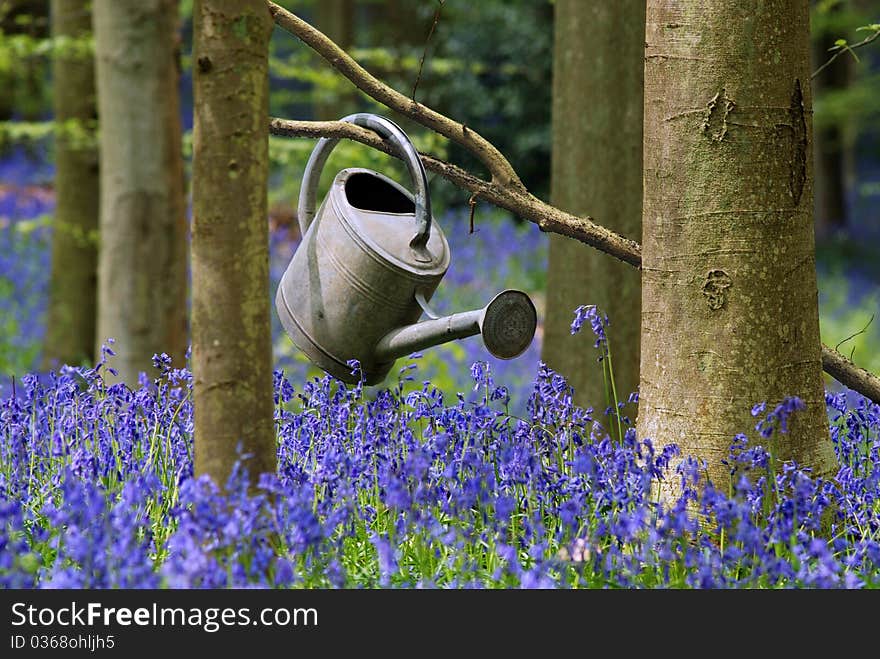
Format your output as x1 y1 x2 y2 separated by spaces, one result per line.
297 112 431 251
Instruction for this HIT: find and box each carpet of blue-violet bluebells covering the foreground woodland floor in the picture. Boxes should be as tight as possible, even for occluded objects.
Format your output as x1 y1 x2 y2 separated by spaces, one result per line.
0 340 880 588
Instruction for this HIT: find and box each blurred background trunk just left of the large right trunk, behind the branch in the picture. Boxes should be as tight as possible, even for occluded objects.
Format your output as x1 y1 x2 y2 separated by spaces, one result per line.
542 0 645 410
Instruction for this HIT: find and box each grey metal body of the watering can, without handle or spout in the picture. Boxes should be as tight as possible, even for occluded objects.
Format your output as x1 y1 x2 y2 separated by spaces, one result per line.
276 168 449 384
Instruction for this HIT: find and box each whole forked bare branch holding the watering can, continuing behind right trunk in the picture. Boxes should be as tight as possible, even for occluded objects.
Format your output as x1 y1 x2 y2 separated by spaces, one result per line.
268 2 880 404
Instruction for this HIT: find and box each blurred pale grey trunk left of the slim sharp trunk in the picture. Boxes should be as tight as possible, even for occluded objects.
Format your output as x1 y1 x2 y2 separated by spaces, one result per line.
94 0 187 386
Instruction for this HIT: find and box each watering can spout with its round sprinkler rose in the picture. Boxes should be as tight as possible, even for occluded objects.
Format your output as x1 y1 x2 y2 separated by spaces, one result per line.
375 290 537 362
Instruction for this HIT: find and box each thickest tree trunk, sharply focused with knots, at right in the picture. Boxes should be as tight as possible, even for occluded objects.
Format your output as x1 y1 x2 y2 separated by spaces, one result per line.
638 0 834 496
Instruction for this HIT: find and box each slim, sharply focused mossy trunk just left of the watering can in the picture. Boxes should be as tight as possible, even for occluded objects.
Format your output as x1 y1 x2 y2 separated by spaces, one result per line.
192 0 276 486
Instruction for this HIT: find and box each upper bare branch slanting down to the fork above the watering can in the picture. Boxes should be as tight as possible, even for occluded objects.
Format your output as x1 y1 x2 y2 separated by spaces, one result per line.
268 2 524 189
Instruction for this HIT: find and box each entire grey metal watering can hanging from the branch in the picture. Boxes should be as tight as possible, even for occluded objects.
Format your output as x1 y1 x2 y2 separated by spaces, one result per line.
275 113 537 384
